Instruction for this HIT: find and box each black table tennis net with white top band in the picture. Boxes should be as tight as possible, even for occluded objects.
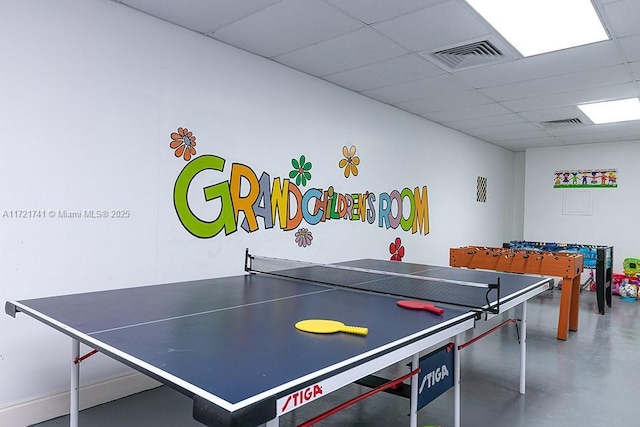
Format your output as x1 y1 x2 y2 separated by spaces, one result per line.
245 252 500 313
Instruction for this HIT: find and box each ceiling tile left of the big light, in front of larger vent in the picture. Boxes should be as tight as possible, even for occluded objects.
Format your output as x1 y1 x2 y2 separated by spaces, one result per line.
373 0 490 52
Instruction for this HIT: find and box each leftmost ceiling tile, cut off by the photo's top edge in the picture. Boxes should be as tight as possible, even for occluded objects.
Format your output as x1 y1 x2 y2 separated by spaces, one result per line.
120 0 280 33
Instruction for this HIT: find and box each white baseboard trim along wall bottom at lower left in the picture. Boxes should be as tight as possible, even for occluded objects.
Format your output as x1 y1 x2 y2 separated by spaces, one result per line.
0 372 161 427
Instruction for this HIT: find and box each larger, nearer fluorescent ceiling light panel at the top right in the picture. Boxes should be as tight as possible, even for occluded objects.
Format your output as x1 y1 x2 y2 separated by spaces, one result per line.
466 0 609 56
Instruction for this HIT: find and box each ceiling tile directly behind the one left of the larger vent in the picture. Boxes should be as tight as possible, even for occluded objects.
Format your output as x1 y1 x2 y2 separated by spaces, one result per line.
362 74 469 104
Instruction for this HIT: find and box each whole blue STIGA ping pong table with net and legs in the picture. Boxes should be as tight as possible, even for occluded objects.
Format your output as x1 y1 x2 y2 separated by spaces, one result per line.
5 251 552 427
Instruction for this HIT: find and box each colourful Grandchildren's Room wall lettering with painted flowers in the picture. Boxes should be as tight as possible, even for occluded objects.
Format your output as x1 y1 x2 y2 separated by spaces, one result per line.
169 128 429 241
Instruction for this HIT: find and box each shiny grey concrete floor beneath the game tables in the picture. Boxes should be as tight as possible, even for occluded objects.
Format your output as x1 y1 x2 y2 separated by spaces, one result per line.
38 289 640 427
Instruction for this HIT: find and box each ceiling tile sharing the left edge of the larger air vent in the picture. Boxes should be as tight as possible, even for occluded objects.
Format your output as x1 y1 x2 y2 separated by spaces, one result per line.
324 54 444 92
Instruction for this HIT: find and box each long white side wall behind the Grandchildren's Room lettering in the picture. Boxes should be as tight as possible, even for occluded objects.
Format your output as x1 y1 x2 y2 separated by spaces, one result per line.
0 0 516 425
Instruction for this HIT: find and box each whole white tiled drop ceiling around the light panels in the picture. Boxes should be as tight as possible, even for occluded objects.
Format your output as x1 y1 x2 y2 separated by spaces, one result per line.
113 0 640 152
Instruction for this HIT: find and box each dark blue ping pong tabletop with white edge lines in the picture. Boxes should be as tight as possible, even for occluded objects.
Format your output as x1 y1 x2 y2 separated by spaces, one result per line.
6 259 548 425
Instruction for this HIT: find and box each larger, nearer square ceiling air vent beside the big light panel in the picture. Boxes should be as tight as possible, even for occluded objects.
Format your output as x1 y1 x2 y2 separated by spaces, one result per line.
432 40 504 70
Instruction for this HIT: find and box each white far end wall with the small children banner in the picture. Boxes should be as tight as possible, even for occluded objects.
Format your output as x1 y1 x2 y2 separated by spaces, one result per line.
524 142 640 272
